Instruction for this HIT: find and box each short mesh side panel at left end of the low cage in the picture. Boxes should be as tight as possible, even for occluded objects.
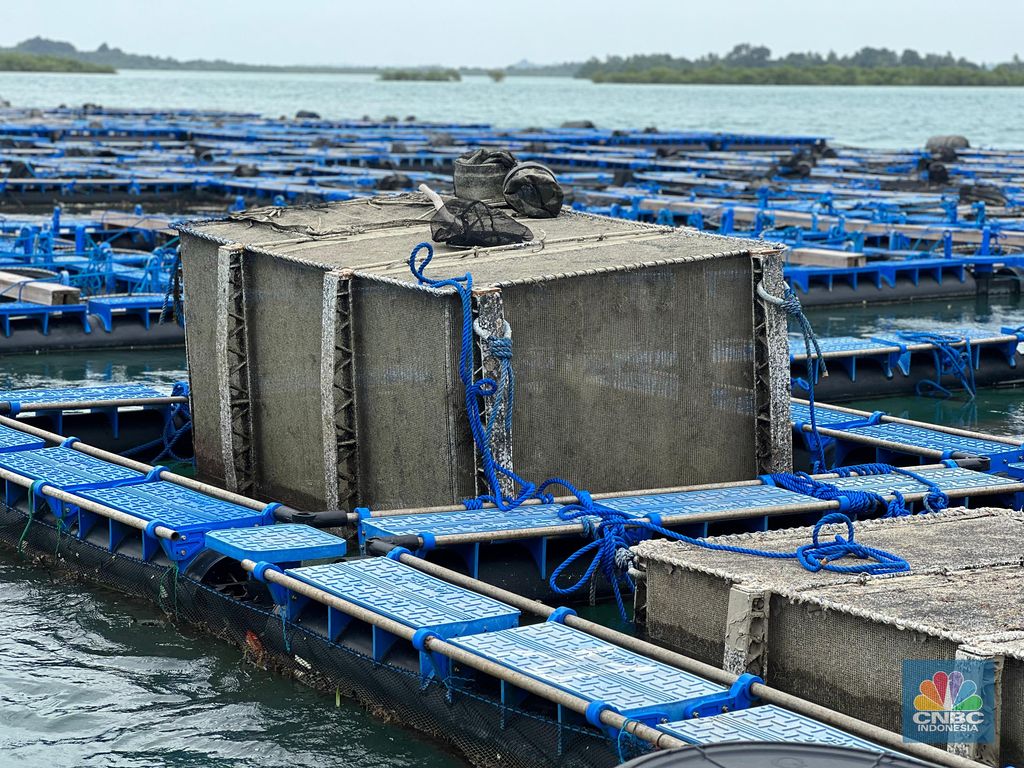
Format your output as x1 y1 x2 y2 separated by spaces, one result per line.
646 561 729 667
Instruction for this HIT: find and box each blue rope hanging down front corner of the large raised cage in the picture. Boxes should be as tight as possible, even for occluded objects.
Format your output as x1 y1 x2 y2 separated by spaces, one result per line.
409 243 538 512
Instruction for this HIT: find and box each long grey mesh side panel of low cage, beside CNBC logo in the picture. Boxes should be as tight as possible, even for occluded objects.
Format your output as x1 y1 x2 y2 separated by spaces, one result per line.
766 595 956 732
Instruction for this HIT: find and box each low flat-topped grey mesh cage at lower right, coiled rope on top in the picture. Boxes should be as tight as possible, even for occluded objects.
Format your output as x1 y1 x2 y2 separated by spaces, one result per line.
635 512 1024 765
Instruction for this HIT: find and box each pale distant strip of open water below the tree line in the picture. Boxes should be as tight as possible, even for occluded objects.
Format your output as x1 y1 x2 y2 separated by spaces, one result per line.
0 70 1024 147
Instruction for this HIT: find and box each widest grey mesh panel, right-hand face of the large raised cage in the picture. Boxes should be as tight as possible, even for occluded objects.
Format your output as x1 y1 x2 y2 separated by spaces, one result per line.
502 256 757 492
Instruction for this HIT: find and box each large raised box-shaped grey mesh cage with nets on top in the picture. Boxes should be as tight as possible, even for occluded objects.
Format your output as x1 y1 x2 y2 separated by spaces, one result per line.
181 195 792 509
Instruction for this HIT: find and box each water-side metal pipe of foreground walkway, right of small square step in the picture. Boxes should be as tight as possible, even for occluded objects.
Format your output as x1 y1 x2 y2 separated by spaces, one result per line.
241 560 689 749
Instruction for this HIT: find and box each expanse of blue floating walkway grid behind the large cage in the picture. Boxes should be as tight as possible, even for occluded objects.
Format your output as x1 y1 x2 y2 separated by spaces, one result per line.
0 109 1024 305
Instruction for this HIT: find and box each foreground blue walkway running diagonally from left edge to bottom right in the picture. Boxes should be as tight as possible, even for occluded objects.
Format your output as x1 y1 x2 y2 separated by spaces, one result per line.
0 417 991 766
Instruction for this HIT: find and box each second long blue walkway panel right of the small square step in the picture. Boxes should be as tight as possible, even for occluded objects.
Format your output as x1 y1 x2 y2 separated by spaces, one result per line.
453 622 756 727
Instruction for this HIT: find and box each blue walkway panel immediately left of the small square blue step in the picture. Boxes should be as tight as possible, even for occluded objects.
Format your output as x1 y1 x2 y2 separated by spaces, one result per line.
77 480 275 563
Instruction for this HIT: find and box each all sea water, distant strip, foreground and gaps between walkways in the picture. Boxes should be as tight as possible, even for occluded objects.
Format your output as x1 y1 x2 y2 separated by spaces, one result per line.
0 72 1024 768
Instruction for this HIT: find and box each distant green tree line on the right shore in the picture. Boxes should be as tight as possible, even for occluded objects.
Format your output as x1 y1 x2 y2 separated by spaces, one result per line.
575 43 1024 86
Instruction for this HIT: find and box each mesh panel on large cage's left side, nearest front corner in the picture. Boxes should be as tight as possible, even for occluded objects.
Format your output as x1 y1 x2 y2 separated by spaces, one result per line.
353 280 476 509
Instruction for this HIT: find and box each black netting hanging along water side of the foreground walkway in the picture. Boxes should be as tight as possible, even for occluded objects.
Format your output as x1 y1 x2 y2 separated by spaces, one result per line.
0 505 645 768
